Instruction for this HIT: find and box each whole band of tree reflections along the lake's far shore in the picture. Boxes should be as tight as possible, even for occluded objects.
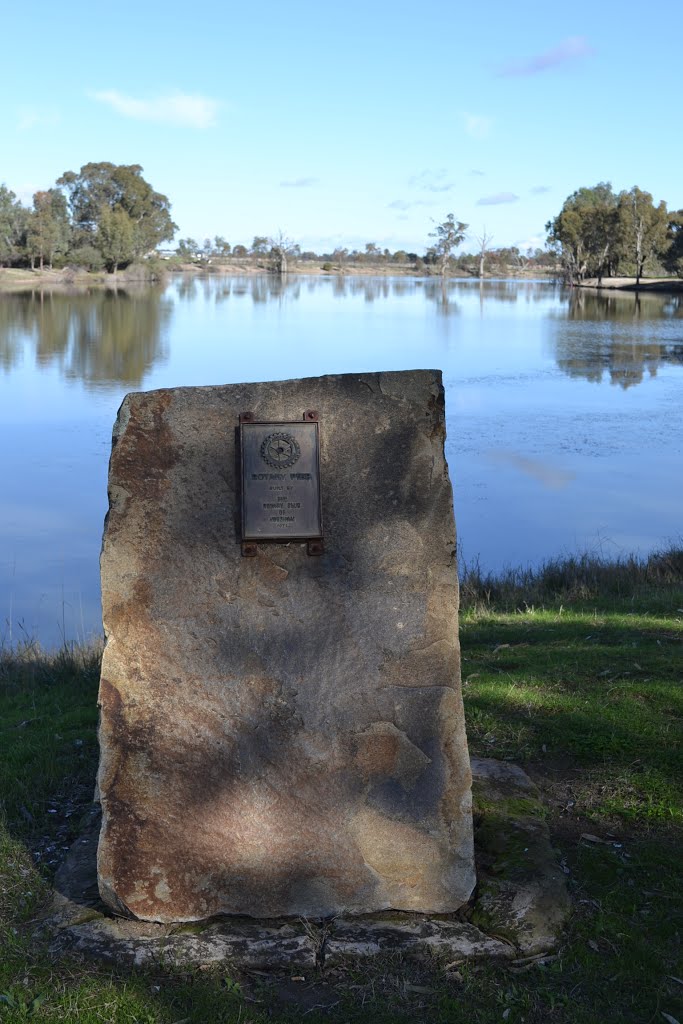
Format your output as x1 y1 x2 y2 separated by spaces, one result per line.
0 274 683 389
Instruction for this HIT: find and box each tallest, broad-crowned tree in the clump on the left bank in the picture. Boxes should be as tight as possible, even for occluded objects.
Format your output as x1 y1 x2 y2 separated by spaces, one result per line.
57 162 177 258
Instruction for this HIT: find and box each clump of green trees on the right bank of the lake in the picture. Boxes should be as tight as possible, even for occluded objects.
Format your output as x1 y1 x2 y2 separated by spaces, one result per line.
546 181 683 284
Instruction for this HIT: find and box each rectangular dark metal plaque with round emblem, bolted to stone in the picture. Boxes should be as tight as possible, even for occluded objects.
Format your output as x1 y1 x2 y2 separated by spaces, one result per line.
240 417 323 542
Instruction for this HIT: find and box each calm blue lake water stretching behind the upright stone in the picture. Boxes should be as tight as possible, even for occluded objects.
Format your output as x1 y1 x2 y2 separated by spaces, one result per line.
0 278 683 646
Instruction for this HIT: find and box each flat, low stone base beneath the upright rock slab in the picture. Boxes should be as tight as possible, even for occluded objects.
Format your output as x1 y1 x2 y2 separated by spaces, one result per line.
40 758 569 973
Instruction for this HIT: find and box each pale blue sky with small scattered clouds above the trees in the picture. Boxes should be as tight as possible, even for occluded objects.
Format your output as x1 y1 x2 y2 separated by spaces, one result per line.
0 0 683 252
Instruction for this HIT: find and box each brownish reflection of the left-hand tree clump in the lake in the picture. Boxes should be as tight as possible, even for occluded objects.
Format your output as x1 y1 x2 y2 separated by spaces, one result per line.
0 289 173 387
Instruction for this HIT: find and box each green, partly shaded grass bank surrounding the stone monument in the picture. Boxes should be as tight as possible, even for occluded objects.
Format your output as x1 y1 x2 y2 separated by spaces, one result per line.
0 551 683 1024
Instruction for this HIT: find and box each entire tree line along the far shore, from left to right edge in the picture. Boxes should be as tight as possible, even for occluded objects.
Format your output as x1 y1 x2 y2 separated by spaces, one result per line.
0 162 683 283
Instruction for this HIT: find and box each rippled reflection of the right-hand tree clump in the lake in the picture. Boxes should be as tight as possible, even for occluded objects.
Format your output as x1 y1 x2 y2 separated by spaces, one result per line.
553 289 683 390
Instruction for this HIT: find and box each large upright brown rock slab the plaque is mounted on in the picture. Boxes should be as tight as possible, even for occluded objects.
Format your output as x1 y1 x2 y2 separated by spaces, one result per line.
98 371 474 923
